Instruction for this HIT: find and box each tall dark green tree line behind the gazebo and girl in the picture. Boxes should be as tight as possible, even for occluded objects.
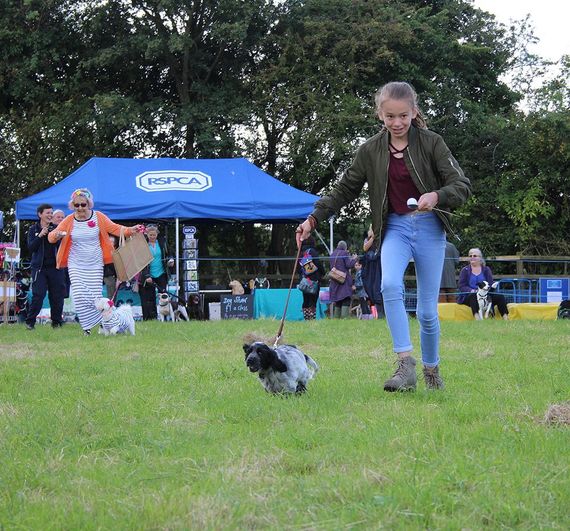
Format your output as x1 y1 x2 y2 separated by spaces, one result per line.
0 0 570 270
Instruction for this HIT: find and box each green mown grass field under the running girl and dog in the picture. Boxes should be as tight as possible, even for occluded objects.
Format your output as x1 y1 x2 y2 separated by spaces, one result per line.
0 320 570 530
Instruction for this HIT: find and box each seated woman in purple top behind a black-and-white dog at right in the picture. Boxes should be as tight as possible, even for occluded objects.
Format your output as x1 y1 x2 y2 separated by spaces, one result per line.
457 247 509 319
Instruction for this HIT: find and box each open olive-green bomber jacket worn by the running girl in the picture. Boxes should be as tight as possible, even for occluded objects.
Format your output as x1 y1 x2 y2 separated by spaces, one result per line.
312 126 471 249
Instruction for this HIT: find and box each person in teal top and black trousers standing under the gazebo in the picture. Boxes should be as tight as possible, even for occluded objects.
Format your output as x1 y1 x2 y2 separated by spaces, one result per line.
139 225 174 321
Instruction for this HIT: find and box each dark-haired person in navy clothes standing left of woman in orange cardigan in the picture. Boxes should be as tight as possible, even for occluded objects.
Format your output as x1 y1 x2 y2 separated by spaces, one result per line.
26 204 65 330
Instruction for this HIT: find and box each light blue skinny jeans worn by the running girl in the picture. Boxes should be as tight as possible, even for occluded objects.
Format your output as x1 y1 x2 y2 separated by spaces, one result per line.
381 212 445 367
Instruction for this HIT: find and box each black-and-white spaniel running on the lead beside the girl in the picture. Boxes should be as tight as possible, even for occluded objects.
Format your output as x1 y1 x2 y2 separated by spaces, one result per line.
243 341 319 394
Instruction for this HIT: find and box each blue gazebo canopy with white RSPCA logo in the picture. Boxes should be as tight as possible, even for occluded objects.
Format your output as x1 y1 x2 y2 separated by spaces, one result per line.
16 157 318 223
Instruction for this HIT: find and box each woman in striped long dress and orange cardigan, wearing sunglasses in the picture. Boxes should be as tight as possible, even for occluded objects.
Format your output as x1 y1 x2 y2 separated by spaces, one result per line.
48 188 144 335
